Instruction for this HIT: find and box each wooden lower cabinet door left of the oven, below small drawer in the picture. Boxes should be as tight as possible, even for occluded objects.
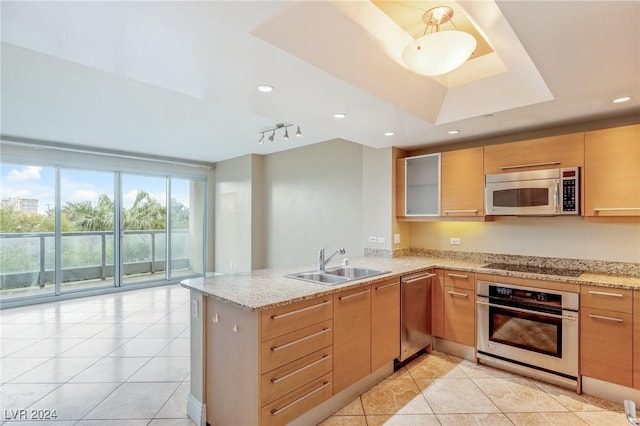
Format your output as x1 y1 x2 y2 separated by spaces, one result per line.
444 287 476 347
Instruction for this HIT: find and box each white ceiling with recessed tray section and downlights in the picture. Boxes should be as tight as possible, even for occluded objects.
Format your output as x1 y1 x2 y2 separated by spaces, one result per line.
0 0 640 162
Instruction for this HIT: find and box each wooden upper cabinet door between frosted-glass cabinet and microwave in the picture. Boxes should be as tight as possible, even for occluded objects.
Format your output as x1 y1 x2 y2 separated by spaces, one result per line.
442 147 484 217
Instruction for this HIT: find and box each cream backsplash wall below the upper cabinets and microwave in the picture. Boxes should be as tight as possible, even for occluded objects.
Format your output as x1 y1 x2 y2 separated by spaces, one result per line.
410 217 640 263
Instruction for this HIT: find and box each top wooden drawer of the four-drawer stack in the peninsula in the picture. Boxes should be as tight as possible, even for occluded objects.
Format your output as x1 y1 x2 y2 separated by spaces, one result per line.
261 296 333 341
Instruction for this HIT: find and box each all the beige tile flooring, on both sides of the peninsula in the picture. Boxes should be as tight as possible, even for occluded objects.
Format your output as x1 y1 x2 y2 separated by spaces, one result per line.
0 285 628 426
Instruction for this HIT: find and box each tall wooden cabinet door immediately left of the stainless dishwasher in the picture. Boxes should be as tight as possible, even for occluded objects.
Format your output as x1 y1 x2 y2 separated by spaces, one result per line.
371 278 400 371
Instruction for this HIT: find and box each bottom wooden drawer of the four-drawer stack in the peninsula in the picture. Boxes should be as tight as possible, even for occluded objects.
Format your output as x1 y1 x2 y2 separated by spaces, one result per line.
261 373 333 426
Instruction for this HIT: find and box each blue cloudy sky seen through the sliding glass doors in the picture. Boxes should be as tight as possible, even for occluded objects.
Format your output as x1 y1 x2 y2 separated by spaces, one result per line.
0 163 189 213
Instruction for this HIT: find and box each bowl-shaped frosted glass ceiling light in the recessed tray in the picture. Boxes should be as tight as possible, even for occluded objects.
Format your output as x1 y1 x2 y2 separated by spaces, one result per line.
402 6 477 76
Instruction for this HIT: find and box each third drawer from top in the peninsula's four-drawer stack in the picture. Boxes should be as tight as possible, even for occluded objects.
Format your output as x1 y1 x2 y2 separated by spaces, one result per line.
261 346 333 405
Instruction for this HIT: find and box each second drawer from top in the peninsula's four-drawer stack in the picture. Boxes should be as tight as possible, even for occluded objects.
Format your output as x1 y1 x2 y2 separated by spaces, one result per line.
261 320 333 373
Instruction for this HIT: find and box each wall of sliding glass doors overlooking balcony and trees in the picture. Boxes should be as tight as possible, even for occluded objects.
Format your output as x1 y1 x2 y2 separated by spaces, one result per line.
0 158 206 306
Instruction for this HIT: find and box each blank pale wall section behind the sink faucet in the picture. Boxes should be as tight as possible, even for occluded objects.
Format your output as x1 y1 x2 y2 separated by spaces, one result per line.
264 140 364 267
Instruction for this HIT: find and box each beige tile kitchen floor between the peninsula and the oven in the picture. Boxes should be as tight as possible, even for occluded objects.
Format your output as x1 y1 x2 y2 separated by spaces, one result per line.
321 352 629 426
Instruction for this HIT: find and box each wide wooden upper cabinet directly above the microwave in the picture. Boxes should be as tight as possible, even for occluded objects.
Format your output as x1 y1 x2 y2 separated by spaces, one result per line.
484 133 584 174
